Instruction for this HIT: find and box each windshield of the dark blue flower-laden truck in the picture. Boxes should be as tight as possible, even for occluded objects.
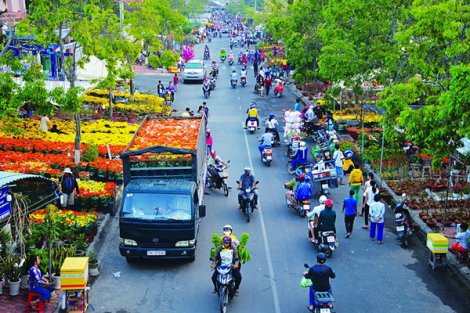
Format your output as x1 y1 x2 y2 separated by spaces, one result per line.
122 193 191 221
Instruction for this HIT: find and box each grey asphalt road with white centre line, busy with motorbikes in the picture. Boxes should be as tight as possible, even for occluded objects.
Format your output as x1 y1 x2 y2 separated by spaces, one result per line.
91 34 470 313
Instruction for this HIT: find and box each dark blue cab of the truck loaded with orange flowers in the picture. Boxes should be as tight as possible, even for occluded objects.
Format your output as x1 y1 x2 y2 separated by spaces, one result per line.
119 179 205 262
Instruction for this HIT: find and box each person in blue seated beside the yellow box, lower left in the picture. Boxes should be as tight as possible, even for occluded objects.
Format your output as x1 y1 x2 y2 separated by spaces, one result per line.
29 255 56 310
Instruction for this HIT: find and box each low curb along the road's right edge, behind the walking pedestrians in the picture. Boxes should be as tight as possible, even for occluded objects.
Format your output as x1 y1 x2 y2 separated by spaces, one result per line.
364 164 470 288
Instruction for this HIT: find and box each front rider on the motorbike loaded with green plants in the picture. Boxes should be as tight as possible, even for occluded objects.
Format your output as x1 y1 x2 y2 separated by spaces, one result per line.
211 236 242 296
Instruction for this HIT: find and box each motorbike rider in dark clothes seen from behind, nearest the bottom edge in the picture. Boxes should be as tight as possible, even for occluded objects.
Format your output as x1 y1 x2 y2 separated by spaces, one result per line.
304 253 336 312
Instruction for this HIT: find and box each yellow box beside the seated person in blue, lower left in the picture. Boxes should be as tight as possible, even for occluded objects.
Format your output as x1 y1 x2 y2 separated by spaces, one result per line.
60 257 88 290
